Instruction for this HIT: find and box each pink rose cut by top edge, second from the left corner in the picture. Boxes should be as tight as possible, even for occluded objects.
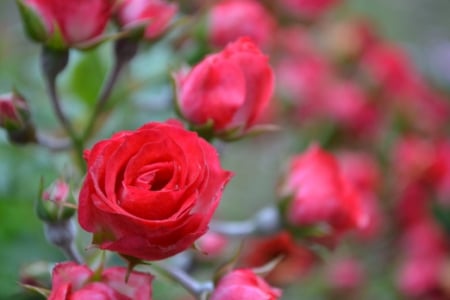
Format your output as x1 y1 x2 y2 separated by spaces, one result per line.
117 0 177 39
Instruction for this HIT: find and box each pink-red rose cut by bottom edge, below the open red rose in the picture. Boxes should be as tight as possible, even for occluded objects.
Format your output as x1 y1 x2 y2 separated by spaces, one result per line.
48 262 153 300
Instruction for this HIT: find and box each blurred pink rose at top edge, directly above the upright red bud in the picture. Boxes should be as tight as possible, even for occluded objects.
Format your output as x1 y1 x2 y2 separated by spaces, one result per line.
208 0 275 48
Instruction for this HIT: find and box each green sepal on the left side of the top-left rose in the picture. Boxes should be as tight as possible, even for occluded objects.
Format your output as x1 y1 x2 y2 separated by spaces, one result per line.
17 0 48 42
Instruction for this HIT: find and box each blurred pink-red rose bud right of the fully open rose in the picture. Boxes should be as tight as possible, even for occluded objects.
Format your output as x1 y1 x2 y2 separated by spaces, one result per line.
280 146 368 236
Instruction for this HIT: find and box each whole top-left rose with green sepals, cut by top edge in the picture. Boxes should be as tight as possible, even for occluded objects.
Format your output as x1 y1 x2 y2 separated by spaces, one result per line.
18 0 114 49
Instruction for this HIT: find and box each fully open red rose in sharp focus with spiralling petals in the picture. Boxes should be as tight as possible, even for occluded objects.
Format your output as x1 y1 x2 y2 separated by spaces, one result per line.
78 122 231 260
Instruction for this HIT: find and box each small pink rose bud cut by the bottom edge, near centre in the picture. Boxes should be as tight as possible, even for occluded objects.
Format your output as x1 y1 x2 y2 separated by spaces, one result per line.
210 269 281 300
